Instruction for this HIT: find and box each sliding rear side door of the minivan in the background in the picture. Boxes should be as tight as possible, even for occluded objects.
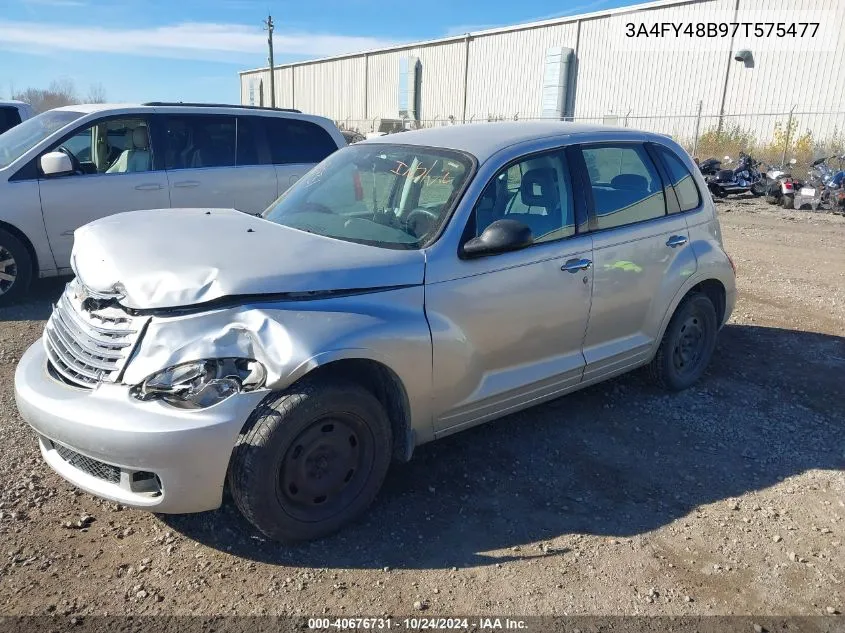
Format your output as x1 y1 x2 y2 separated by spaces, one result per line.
163 114 241 208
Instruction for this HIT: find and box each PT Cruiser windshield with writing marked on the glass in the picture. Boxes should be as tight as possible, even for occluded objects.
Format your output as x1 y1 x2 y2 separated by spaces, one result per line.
263 143 473 249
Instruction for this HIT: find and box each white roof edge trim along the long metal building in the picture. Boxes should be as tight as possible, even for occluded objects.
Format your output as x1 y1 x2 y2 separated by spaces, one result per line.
238 0 713 75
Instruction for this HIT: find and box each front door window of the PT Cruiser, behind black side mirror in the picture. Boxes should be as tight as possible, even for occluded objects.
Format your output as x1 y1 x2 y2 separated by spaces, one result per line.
470 152 575 243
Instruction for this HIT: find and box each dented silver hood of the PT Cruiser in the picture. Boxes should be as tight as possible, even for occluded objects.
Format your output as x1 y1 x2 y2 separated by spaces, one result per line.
71 209 425 309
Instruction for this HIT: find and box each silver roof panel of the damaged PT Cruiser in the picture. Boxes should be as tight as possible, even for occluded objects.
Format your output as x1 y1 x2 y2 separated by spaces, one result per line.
356 120 645 163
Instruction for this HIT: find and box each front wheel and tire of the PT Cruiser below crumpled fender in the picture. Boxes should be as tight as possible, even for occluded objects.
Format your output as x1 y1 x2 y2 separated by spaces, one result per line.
229 379 393 542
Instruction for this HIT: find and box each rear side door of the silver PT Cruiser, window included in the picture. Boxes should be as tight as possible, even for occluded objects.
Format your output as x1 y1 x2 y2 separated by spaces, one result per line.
578 143 696 382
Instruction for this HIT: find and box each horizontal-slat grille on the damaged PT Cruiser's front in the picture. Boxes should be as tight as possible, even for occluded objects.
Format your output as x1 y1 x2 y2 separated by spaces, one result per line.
44 279 143 387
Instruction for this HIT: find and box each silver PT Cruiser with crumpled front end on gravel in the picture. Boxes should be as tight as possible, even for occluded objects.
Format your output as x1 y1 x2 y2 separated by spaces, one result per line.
15 122 736 540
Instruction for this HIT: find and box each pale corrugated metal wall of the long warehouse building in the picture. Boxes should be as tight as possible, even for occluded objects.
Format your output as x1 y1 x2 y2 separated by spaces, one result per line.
241 0 845 138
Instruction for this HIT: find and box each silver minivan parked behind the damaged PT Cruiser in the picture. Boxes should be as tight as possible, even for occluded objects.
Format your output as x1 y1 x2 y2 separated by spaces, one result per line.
0 103 346 305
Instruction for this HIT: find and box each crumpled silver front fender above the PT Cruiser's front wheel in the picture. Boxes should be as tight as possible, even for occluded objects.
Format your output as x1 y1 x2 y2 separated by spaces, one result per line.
122 285 432 436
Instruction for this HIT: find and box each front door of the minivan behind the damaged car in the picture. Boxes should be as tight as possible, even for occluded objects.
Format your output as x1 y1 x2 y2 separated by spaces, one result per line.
38 114 170 269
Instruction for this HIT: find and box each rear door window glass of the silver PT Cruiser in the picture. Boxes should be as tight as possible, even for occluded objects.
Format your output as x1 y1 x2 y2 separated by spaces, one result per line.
582 144 666 230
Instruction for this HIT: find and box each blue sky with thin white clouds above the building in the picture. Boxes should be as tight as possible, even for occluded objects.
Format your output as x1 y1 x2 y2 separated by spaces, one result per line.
0 0 642 102
